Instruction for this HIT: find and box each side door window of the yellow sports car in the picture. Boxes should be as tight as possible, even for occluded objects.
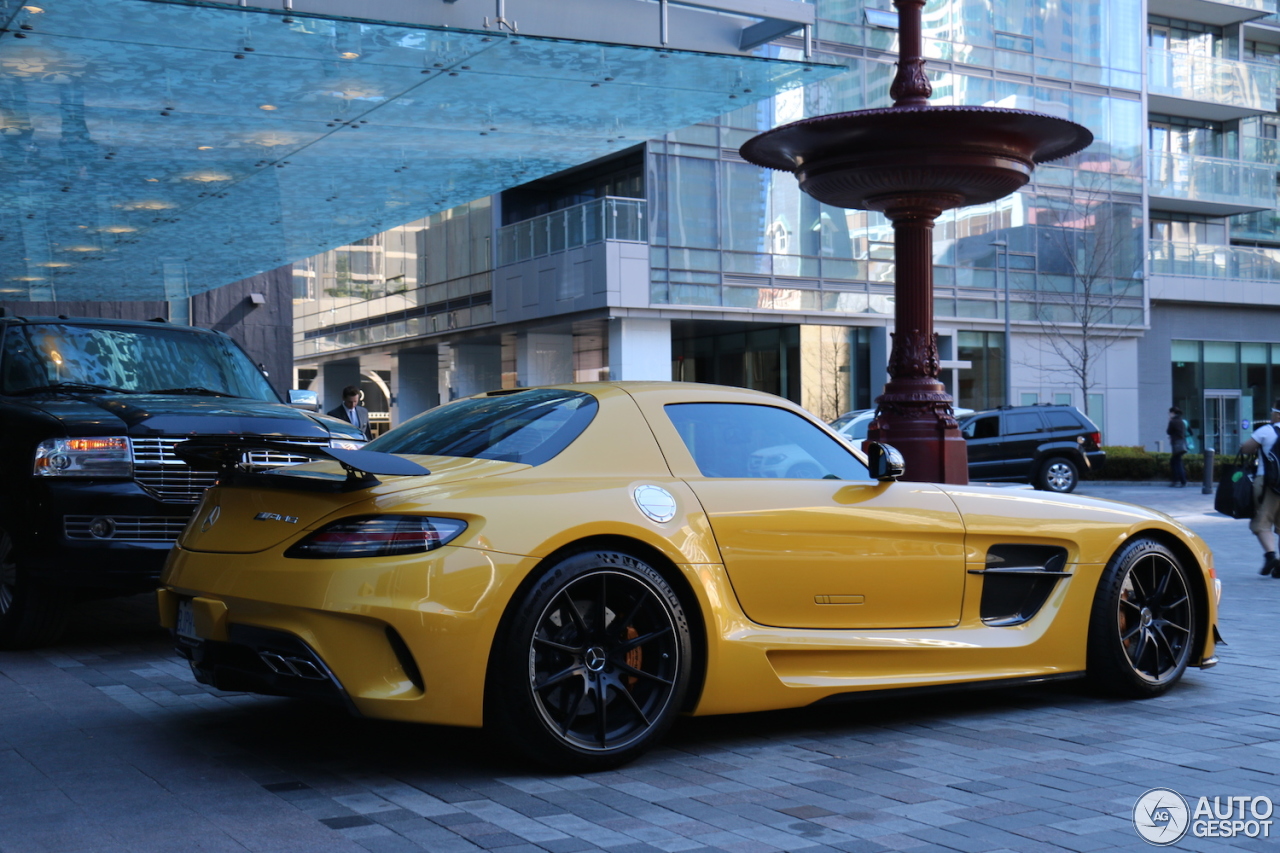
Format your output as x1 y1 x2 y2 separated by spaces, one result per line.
666 403 870 480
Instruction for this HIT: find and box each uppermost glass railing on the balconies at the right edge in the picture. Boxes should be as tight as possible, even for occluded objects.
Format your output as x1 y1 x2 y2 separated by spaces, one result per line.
1147 50 1280 113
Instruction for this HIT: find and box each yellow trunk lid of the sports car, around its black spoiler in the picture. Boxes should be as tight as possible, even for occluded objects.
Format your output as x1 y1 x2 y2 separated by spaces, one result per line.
178 455 530 550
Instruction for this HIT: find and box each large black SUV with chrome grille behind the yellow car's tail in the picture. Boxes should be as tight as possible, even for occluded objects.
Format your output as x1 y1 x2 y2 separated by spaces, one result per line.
0 316 364 648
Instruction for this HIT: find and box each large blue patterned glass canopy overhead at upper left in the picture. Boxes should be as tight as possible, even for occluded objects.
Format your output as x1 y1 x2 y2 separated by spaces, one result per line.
0 0 844 301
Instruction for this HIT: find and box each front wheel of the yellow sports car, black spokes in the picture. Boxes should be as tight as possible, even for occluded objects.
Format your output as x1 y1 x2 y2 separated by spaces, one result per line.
1087 538 1199 699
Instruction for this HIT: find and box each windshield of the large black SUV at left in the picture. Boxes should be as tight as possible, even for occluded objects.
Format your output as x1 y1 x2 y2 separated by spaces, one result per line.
0 323 279 402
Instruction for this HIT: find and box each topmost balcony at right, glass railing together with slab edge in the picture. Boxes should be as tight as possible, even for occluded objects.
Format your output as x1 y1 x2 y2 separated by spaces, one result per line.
1147 50 1280 122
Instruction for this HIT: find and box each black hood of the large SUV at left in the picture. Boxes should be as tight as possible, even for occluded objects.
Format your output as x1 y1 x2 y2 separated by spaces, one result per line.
27 394 364 441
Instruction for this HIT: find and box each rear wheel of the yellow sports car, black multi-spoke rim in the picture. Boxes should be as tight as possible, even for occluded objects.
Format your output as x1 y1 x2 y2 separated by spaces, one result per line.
485 549 692 772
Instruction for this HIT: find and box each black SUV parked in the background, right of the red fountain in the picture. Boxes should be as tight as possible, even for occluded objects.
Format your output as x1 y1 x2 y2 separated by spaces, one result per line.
960 405 1107 492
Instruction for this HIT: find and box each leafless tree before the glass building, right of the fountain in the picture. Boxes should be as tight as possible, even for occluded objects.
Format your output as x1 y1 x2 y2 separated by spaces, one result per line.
1010 173 1143 406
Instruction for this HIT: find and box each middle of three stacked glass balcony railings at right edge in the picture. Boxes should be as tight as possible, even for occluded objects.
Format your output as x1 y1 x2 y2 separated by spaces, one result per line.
1147 151 1276 207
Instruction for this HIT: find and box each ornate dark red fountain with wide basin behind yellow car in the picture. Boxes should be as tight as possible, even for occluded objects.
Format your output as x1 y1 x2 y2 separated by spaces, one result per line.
741 0 1093 483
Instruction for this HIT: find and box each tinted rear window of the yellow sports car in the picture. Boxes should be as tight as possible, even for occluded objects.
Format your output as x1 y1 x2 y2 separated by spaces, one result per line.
365 389 598 465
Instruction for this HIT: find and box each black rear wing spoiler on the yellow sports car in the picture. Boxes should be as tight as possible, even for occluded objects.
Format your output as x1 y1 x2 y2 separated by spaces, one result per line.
173 435 431 492
